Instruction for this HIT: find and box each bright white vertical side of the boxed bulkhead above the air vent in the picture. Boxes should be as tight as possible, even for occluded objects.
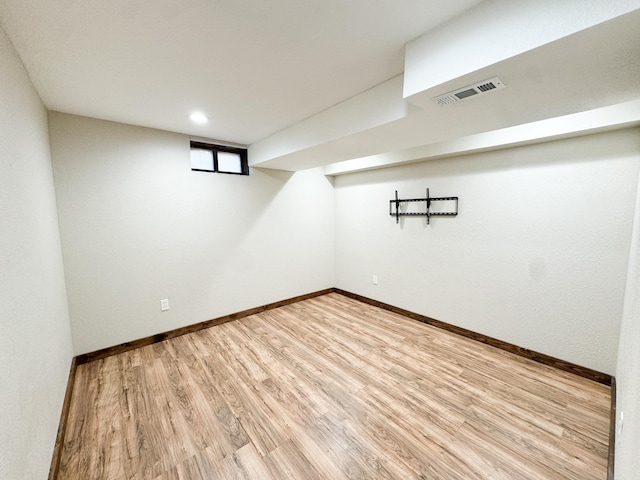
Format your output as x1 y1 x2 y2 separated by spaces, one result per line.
403 0 640 100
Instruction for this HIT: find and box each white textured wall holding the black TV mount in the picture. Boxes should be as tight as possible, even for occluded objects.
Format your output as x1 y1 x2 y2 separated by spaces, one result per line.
335 129 640 374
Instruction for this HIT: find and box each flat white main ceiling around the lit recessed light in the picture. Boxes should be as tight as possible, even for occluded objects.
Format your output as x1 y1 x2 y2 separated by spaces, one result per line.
0 0 480 145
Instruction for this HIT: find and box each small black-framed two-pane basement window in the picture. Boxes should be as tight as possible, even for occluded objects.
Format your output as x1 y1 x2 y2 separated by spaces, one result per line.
191 141 249 175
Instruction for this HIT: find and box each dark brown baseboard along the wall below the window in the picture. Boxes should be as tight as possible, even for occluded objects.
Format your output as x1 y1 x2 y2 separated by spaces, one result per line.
76 288 335 365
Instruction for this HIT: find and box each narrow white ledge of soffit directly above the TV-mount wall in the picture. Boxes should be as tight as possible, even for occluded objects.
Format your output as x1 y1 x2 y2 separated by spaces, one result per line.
324 100 640 176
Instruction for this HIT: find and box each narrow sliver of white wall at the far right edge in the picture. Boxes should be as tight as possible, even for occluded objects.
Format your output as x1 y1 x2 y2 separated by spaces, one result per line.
615 160 640 480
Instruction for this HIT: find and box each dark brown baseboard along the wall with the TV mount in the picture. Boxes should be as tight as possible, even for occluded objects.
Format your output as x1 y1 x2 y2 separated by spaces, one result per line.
334 288 612 386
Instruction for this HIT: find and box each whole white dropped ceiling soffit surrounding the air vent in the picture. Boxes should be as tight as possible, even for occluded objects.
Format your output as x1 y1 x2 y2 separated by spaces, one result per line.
249 0 640 171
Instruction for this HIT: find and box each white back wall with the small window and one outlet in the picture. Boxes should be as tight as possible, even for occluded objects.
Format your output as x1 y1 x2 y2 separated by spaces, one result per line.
49 113 334 354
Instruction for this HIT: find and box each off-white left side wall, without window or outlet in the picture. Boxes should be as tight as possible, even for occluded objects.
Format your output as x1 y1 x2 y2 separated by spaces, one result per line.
0 23 72 480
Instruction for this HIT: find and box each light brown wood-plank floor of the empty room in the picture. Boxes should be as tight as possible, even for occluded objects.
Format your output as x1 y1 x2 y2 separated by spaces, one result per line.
58 293 610 480
